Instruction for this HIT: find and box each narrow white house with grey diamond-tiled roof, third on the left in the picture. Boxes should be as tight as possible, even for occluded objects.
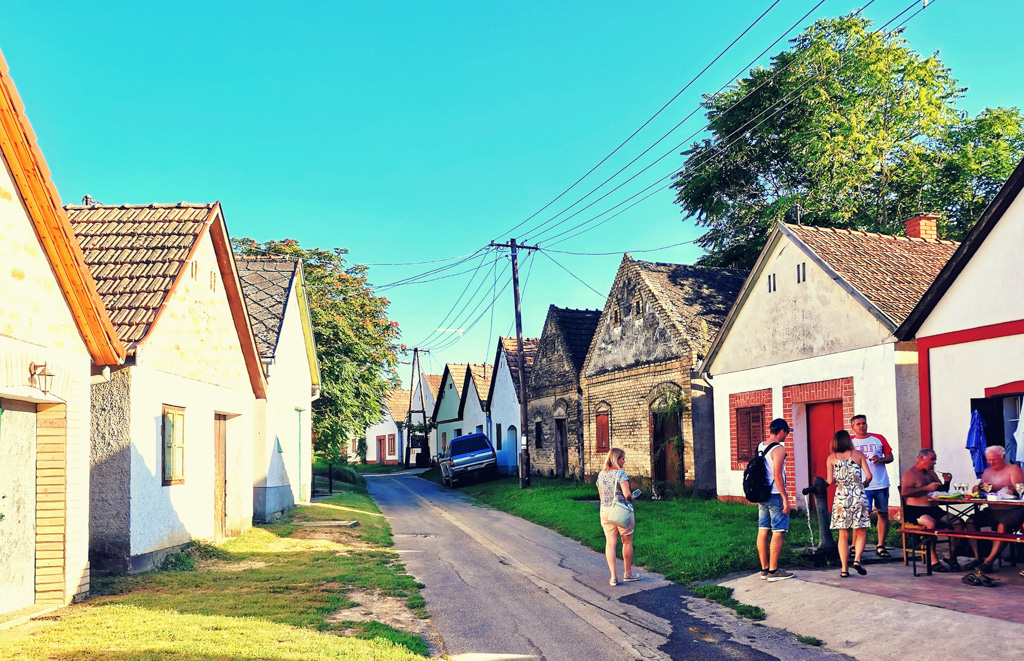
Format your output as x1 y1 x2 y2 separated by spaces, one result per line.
236 257 319 522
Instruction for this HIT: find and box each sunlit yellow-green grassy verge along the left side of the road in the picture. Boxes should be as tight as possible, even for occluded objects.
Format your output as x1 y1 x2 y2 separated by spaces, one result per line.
0 484 427 660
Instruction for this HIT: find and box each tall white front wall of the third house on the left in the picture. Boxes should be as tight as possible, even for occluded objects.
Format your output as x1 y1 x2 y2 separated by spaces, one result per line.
253 287 312 521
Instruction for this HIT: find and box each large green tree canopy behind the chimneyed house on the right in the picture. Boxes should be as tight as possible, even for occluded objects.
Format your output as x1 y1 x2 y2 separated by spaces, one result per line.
674 14 1024 267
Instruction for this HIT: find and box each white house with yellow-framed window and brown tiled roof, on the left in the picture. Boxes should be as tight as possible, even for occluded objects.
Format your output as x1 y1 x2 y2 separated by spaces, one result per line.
66 203 268 571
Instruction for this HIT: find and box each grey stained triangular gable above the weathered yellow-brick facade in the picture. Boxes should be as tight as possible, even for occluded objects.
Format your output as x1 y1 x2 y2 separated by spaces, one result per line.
584 264 688 377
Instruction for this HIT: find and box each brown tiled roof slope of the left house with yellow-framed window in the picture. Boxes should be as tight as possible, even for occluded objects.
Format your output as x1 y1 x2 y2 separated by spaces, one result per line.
65 203 215 344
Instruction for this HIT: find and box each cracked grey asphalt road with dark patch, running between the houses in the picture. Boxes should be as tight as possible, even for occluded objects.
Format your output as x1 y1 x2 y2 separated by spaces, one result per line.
367 474 847 661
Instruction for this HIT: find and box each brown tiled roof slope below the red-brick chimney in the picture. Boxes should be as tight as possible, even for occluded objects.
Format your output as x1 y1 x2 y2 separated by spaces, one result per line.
785 225 959 325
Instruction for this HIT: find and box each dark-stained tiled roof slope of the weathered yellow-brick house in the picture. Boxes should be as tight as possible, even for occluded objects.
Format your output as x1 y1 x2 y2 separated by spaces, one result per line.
634 261 748 342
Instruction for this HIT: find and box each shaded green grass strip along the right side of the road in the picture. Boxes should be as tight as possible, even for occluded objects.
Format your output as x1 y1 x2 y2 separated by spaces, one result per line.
452 477 816 584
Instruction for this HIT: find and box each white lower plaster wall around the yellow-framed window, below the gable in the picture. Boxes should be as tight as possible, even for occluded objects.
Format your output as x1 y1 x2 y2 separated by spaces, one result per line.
130 368 255 569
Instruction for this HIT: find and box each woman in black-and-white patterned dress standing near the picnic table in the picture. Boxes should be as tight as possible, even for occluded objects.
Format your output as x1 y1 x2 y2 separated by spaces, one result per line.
827 430 871 578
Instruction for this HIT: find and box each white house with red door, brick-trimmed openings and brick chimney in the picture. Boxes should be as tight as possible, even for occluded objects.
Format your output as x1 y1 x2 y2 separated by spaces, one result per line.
701 218 956 505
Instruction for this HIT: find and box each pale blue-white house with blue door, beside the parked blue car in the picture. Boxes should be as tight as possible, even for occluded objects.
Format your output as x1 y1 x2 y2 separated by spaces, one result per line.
485 338 539 475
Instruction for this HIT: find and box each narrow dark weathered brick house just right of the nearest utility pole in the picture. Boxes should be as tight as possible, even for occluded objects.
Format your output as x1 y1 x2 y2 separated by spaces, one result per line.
526 305 601 477
